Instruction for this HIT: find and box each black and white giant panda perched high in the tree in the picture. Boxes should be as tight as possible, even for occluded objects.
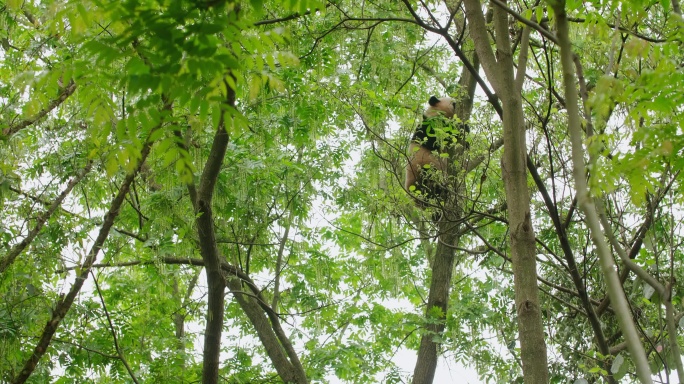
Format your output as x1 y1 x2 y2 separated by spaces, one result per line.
404 96 469 207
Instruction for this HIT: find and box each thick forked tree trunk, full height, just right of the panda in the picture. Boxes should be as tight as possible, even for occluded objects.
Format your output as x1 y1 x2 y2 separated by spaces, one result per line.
464 0 548 384
